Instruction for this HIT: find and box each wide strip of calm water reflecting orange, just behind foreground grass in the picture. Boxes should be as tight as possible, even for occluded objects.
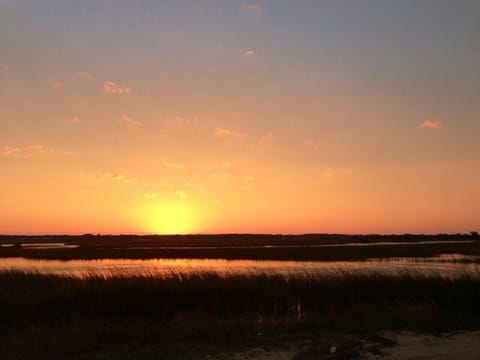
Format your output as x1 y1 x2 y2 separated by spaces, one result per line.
0 255 480 278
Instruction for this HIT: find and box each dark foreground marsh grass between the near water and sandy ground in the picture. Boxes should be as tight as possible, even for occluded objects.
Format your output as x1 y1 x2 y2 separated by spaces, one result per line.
0 272 480 359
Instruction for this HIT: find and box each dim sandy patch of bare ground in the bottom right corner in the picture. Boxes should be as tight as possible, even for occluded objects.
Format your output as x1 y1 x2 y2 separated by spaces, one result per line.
205 331 480 360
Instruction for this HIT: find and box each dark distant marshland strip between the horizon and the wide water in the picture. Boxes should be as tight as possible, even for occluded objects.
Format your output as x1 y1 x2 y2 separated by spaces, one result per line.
0 234 480 261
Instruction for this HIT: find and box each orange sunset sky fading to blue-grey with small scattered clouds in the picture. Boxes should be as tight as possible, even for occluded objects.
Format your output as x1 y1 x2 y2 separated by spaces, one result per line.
0 0 480 234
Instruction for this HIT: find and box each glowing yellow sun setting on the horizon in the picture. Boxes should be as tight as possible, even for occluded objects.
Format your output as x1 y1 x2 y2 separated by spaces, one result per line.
141 201 200 235
